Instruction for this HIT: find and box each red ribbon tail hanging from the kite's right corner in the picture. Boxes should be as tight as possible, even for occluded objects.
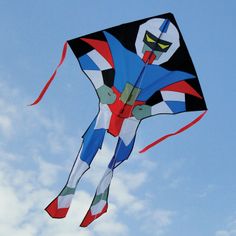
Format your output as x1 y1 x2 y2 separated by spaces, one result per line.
139 111 207 153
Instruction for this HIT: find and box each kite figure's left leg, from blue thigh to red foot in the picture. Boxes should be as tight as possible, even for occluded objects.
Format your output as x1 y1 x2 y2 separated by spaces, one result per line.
45 118 106 218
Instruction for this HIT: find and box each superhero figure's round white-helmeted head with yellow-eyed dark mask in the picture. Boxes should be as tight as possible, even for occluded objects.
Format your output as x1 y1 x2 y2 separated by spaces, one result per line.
135 18 180 65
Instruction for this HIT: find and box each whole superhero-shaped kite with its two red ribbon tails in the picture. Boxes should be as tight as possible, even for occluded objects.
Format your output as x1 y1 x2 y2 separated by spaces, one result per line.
31 13 207 227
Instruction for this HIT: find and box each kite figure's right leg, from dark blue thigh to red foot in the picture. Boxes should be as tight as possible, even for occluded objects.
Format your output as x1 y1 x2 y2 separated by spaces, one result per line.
80 137 135 227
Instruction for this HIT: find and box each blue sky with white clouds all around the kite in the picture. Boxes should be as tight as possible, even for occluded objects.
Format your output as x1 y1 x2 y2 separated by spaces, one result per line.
0 0 236 236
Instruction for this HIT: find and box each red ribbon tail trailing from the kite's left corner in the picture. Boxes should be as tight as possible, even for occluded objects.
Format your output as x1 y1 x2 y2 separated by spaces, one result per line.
29 42 68 106
